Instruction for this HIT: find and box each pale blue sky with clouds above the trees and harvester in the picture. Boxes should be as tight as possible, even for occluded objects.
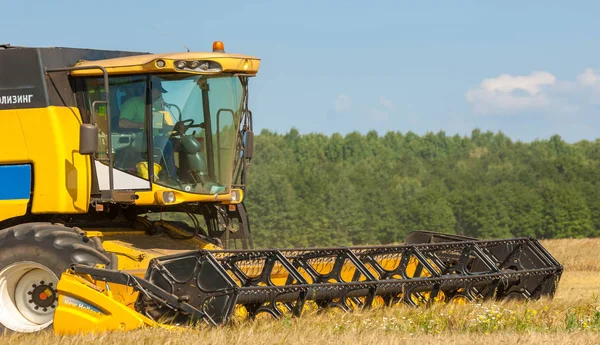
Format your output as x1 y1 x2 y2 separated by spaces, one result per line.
0 0 600 142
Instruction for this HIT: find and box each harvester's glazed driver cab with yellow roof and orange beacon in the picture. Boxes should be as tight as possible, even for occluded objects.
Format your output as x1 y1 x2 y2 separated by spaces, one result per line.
72 42 255 248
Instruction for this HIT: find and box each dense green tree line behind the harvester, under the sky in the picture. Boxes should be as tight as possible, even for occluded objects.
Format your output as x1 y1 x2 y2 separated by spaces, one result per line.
245 129 600 247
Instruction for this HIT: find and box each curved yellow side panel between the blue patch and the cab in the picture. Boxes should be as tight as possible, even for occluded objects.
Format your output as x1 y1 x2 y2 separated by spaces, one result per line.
17 107 91 213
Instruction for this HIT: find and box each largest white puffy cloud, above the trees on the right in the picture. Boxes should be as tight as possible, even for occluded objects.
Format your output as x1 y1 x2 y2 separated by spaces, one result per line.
465 71 557 113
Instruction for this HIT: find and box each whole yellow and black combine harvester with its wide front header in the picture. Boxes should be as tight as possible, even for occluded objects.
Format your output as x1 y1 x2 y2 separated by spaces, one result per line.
0 42 562 334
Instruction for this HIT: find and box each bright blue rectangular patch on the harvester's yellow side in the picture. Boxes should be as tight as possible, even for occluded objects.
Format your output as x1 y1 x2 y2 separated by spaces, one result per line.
0 164 31 200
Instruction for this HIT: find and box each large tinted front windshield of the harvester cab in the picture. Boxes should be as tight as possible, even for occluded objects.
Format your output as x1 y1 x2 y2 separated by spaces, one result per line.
153 74 243 194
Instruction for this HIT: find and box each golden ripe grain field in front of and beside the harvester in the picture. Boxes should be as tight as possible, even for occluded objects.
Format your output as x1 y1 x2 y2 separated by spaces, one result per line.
0 239 600 345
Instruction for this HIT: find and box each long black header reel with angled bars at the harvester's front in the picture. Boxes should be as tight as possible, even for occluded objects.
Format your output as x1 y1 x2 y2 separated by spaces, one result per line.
127 239 562 323
